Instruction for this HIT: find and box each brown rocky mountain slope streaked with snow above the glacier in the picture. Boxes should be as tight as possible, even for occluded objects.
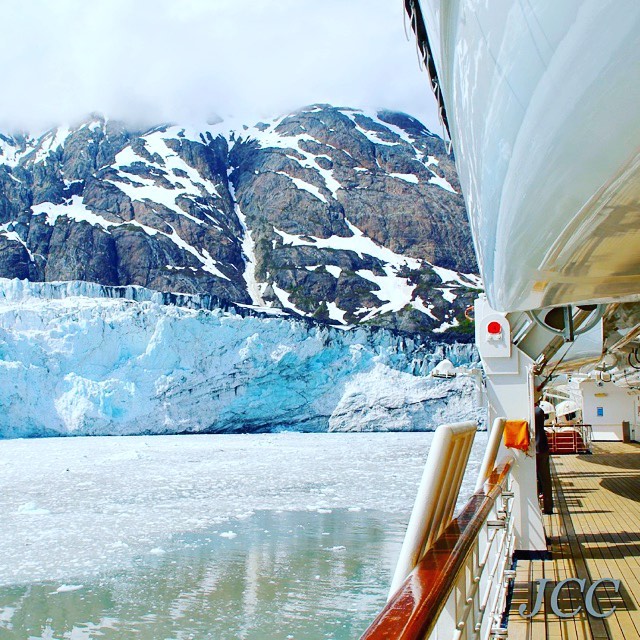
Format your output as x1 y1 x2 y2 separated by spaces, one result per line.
0 105 480 340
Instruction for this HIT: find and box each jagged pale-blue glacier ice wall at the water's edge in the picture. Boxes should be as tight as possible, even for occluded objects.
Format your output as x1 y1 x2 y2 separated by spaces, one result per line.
0 280 479 437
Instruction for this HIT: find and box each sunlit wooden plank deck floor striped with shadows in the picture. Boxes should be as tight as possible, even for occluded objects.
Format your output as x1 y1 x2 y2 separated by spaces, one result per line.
508 442 640 640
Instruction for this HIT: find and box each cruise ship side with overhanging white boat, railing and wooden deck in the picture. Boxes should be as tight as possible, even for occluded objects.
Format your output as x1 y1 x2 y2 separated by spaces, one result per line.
362 0 640 640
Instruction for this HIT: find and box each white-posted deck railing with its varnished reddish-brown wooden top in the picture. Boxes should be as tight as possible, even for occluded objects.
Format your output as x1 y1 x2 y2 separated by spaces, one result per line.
361 454 514 640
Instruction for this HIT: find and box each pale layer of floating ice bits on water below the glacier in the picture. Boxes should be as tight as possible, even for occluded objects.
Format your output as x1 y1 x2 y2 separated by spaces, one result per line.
0 433 486 590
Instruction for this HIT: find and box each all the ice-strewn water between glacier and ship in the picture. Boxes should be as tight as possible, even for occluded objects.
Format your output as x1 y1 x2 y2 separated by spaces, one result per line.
0 434 486 640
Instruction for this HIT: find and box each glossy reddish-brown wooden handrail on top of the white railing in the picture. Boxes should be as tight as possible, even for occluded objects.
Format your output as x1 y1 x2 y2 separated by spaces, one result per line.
361 455 513 640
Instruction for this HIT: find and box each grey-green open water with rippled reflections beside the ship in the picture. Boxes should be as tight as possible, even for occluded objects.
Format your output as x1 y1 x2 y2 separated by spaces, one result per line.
0 510 406 640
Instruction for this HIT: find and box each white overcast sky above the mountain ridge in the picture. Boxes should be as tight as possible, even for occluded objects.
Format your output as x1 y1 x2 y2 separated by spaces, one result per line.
0 0 441 133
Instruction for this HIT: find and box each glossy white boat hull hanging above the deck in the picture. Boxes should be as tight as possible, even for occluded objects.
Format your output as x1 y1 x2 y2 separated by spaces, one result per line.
421 0 640 311
